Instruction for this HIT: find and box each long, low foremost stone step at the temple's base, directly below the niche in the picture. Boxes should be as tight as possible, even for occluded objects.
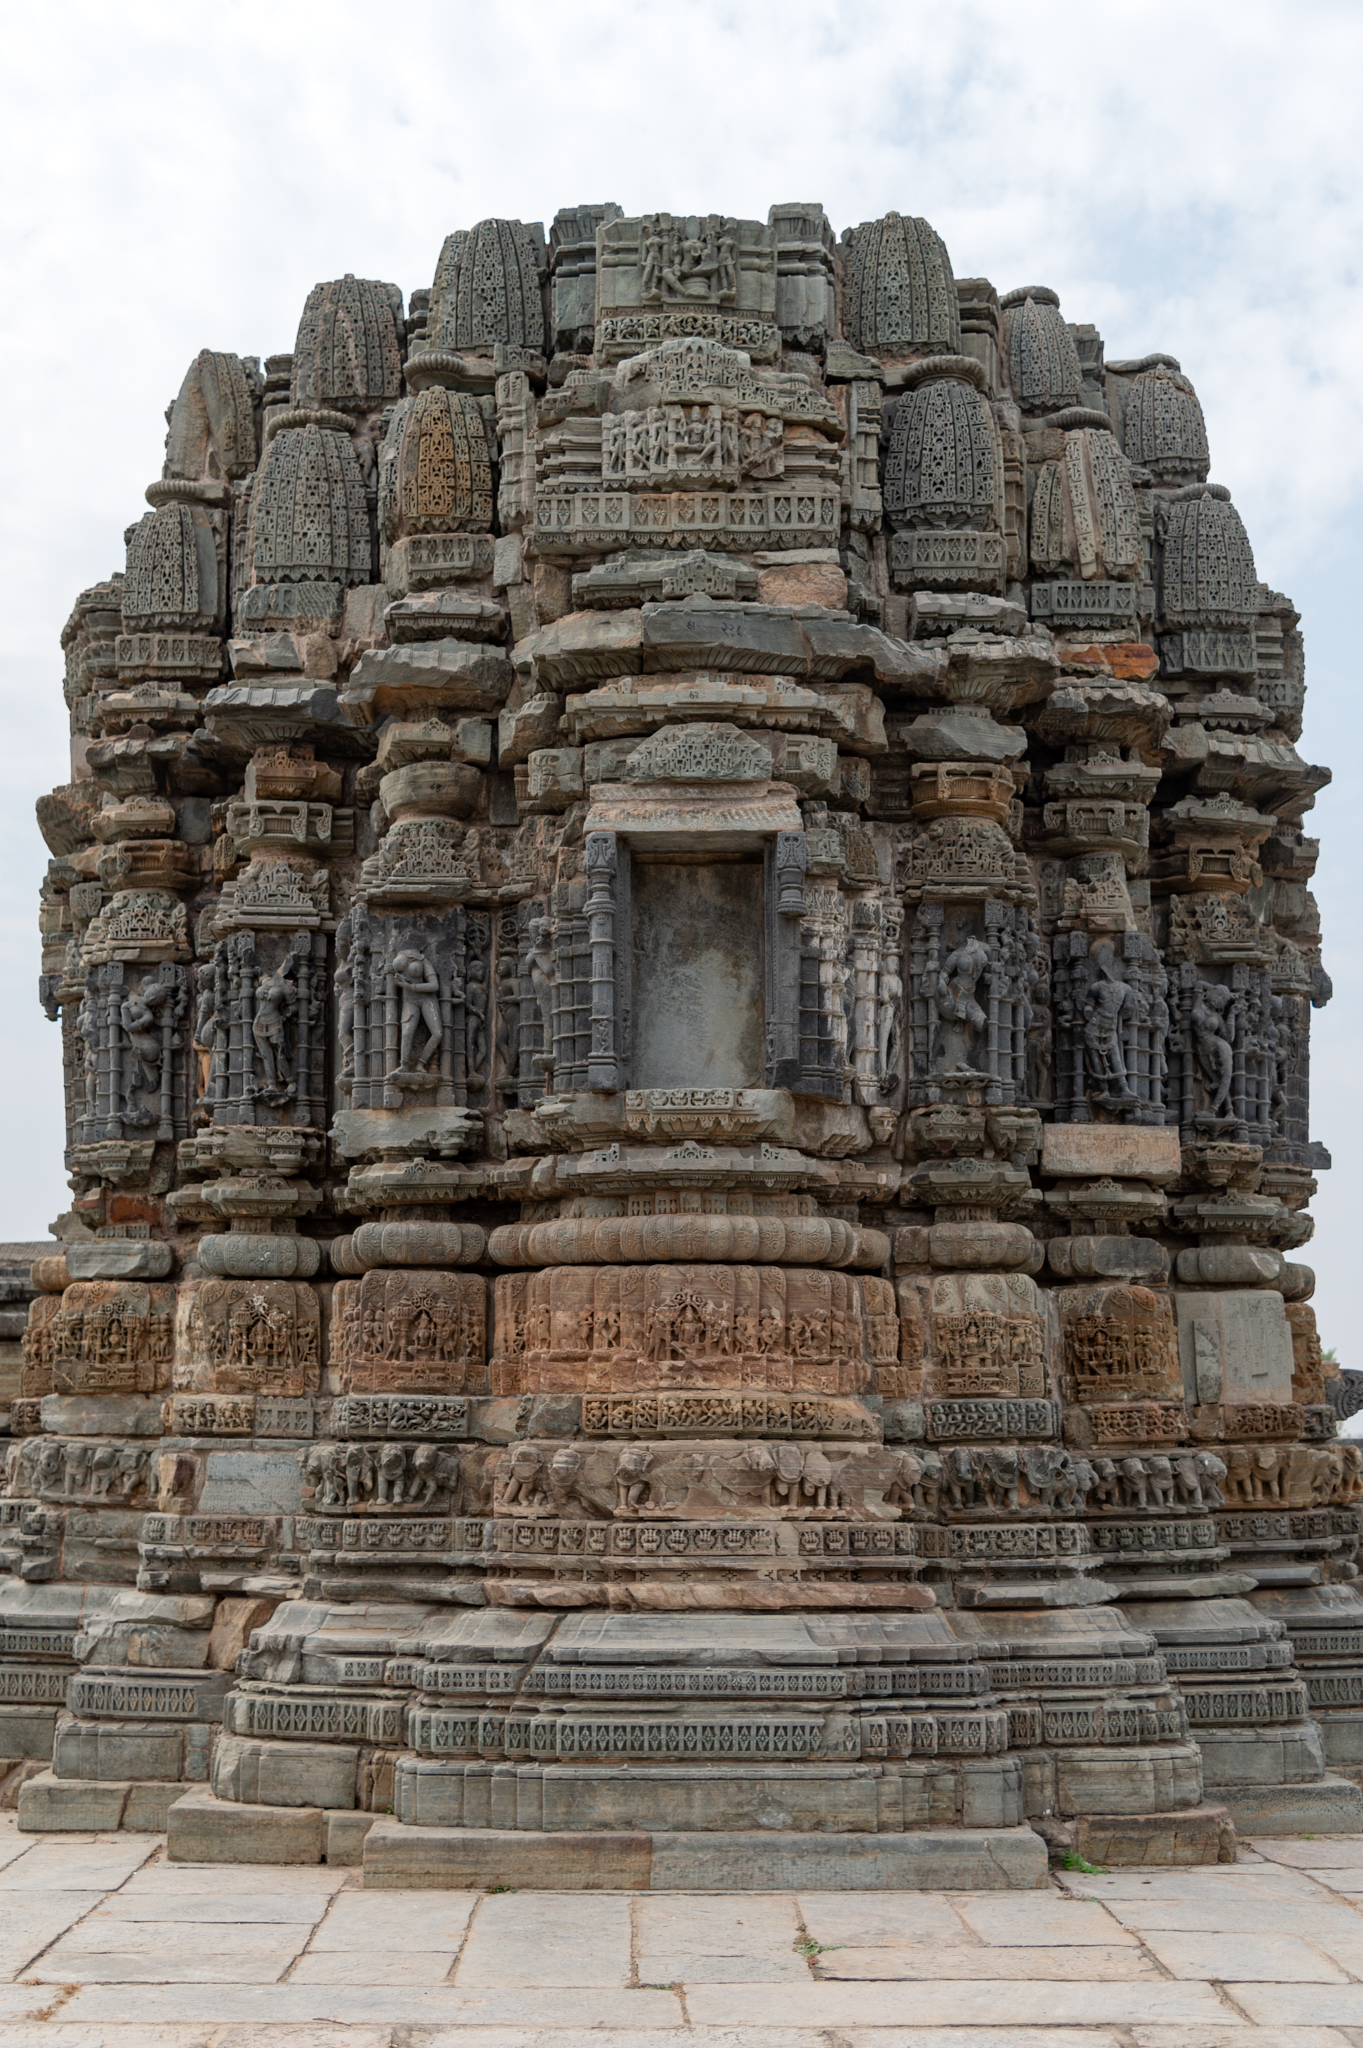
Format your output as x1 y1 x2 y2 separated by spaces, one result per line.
364 1821 1048 1892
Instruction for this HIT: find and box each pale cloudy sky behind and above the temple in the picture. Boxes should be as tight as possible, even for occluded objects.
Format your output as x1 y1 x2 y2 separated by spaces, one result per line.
0 0 1363 1366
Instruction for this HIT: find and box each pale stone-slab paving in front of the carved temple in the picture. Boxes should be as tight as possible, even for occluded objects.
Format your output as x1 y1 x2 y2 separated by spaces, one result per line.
0 1815 1363 2048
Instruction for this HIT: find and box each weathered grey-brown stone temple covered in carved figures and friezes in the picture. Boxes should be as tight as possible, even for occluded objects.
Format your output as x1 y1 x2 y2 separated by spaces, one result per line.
0 205 1363 1888
